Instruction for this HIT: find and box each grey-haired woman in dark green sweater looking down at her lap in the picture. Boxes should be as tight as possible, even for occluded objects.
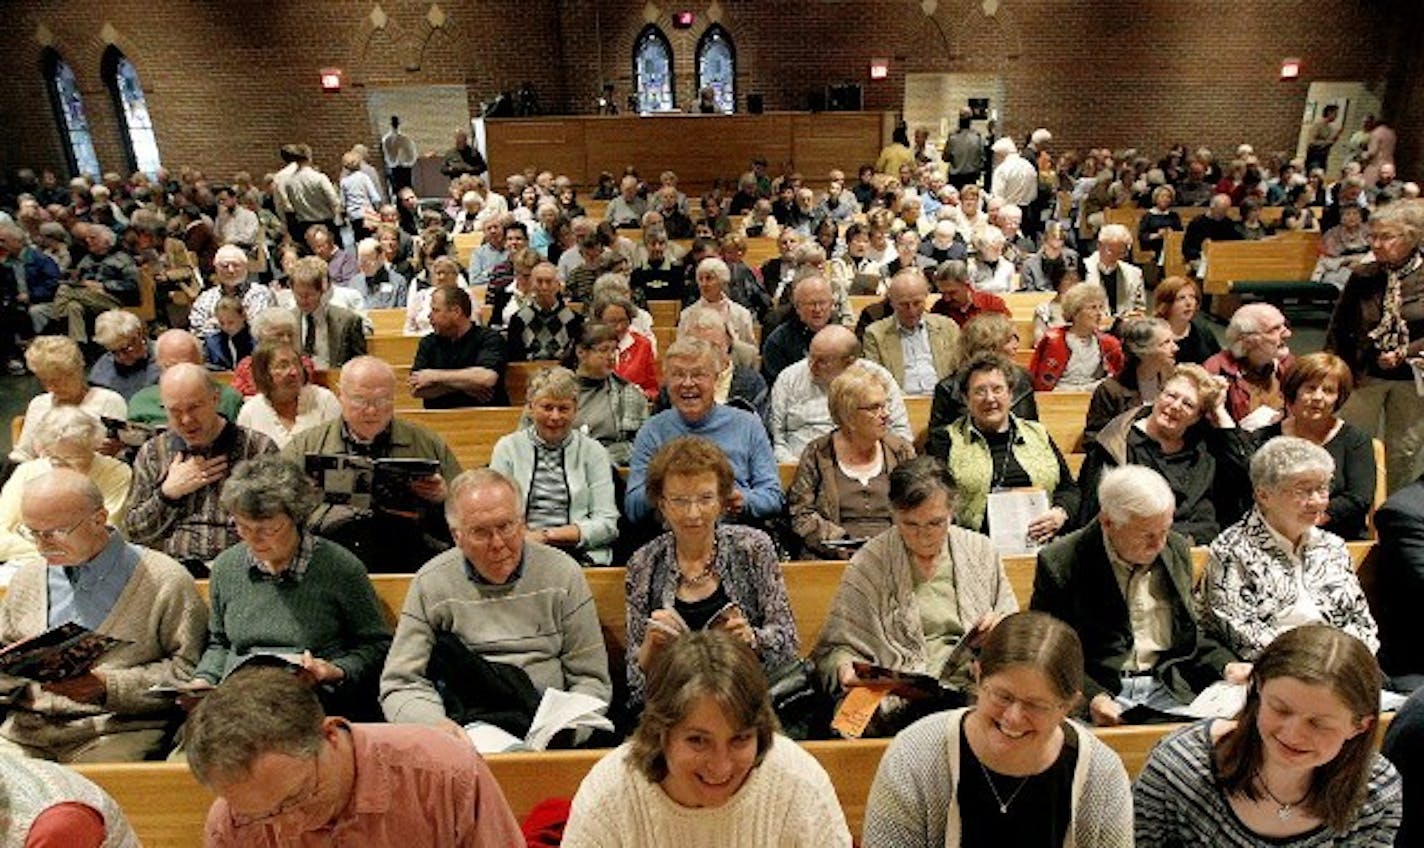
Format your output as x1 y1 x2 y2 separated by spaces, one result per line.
188 454 390 720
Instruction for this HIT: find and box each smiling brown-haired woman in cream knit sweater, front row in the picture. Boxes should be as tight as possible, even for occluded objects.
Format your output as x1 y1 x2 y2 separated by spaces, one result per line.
562 633 850 848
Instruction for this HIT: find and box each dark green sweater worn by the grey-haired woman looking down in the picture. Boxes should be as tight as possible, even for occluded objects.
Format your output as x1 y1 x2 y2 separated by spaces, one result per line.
195 538 390 702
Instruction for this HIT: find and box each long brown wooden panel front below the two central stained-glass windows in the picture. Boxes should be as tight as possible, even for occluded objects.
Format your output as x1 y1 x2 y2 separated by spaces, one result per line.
486 112 887 192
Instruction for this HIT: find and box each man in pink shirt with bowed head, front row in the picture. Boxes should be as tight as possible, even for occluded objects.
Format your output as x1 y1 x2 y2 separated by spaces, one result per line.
187 667 524 848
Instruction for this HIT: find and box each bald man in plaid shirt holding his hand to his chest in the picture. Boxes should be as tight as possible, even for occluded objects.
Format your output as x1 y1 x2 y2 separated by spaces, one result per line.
124 361 276 576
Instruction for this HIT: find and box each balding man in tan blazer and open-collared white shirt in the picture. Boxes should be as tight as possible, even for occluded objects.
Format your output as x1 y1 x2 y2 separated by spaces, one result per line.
864 267 960 396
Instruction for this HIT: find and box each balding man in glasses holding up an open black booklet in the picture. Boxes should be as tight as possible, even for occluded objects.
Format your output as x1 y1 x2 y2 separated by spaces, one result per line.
283 356 460 572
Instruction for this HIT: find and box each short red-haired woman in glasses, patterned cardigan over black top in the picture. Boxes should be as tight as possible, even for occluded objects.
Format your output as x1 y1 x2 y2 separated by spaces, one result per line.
627 435 800 713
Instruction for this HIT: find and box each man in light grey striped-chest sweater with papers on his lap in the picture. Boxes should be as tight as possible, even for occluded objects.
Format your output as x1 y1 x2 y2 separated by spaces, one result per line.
380 468 612 736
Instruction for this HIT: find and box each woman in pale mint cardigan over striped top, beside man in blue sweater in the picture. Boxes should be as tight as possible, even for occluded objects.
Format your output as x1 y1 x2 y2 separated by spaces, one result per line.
490 369 618 565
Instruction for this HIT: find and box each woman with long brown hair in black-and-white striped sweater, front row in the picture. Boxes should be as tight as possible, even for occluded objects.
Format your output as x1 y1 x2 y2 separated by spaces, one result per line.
1132 625 1403 848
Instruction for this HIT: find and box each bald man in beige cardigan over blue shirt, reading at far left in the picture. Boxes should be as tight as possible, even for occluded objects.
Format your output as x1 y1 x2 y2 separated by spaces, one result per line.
0 468 208 763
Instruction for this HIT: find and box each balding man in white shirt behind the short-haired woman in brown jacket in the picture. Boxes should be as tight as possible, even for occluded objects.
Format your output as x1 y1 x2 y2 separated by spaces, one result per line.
772 319 911 462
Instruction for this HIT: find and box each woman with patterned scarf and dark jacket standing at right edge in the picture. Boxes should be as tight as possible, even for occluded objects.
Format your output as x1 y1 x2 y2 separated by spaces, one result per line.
1324 201 1424 492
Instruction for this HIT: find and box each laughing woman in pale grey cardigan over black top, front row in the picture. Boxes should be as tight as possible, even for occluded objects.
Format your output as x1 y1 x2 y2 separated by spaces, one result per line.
862 612 1132 848
